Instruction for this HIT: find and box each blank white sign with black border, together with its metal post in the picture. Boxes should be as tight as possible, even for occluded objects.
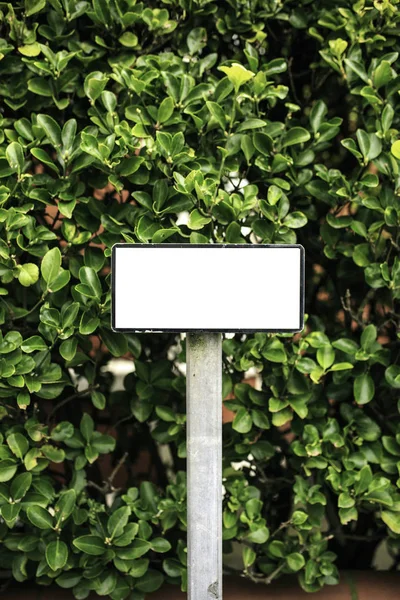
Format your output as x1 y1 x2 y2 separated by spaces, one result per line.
111 244 304 600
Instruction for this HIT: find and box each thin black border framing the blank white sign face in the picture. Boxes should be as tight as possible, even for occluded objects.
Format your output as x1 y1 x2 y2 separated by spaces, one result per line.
111 243 305 333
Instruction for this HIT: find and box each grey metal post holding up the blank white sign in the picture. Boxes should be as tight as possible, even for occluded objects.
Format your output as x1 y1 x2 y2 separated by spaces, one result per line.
186 333 222 600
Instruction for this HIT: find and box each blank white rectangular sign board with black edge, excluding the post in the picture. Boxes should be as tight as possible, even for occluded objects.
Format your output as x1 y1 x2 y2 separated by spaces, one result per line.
112 244 304 332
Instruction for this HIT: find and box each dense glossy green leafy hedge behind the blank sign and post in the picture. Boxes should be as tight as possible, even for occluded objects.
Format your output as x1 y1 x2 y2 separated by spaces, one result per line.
0 0 400 600
